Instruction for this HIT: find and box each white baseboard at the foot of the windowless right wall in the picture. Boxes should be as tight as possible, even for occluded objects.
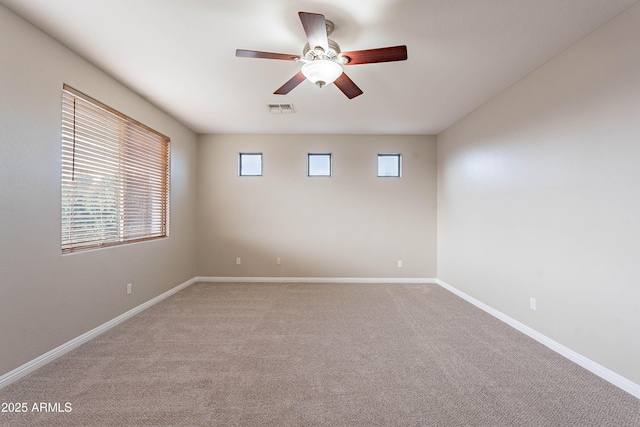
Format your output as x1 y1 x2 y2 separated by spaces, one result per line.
436 279 640 399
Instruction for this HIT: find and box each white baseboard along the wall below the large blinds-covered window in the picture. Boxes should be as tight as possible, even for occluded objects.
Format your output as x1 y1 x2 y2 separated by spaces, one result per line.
0 277 196 389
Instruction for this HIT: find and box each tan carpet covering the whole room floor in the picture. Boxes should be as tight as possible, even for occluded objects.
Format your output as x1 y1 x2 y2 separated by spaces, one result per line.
0 283 640 426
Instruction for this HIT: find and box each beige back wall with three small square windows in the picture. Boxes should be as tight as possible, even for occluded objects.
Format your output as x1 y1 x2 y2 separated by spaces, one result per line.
198 135 436 278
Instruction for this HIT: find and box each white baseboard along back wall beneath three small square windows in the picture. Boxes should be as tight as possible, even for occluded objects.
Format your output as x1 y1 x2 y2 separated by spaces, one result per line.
195 276 437 284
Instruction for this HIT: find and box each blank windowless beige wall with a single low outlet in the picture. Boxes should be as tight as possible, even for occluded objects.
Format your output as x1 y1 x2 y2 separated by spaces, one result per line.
438 5 640 383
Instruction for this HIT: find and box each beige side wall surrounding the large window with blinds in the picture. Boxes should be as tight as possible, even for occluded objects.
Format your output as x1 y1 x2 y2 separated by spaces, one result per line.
0 6 197 375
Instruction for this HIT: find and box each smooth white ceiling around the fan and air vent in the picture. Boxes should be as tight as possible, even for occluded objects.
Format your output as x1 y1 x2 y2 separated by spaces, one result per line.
0 0 638 134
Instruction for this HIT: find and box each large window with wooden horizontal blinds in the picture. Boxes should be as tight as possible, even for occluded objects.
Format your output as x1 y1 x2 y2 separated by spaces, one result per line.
62 85 170 253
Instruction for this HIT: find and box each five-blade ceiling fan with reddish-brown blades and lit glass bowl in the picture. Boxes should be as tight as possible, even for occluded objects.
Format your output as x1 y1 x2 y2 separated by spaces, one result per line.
236 12 407 99
